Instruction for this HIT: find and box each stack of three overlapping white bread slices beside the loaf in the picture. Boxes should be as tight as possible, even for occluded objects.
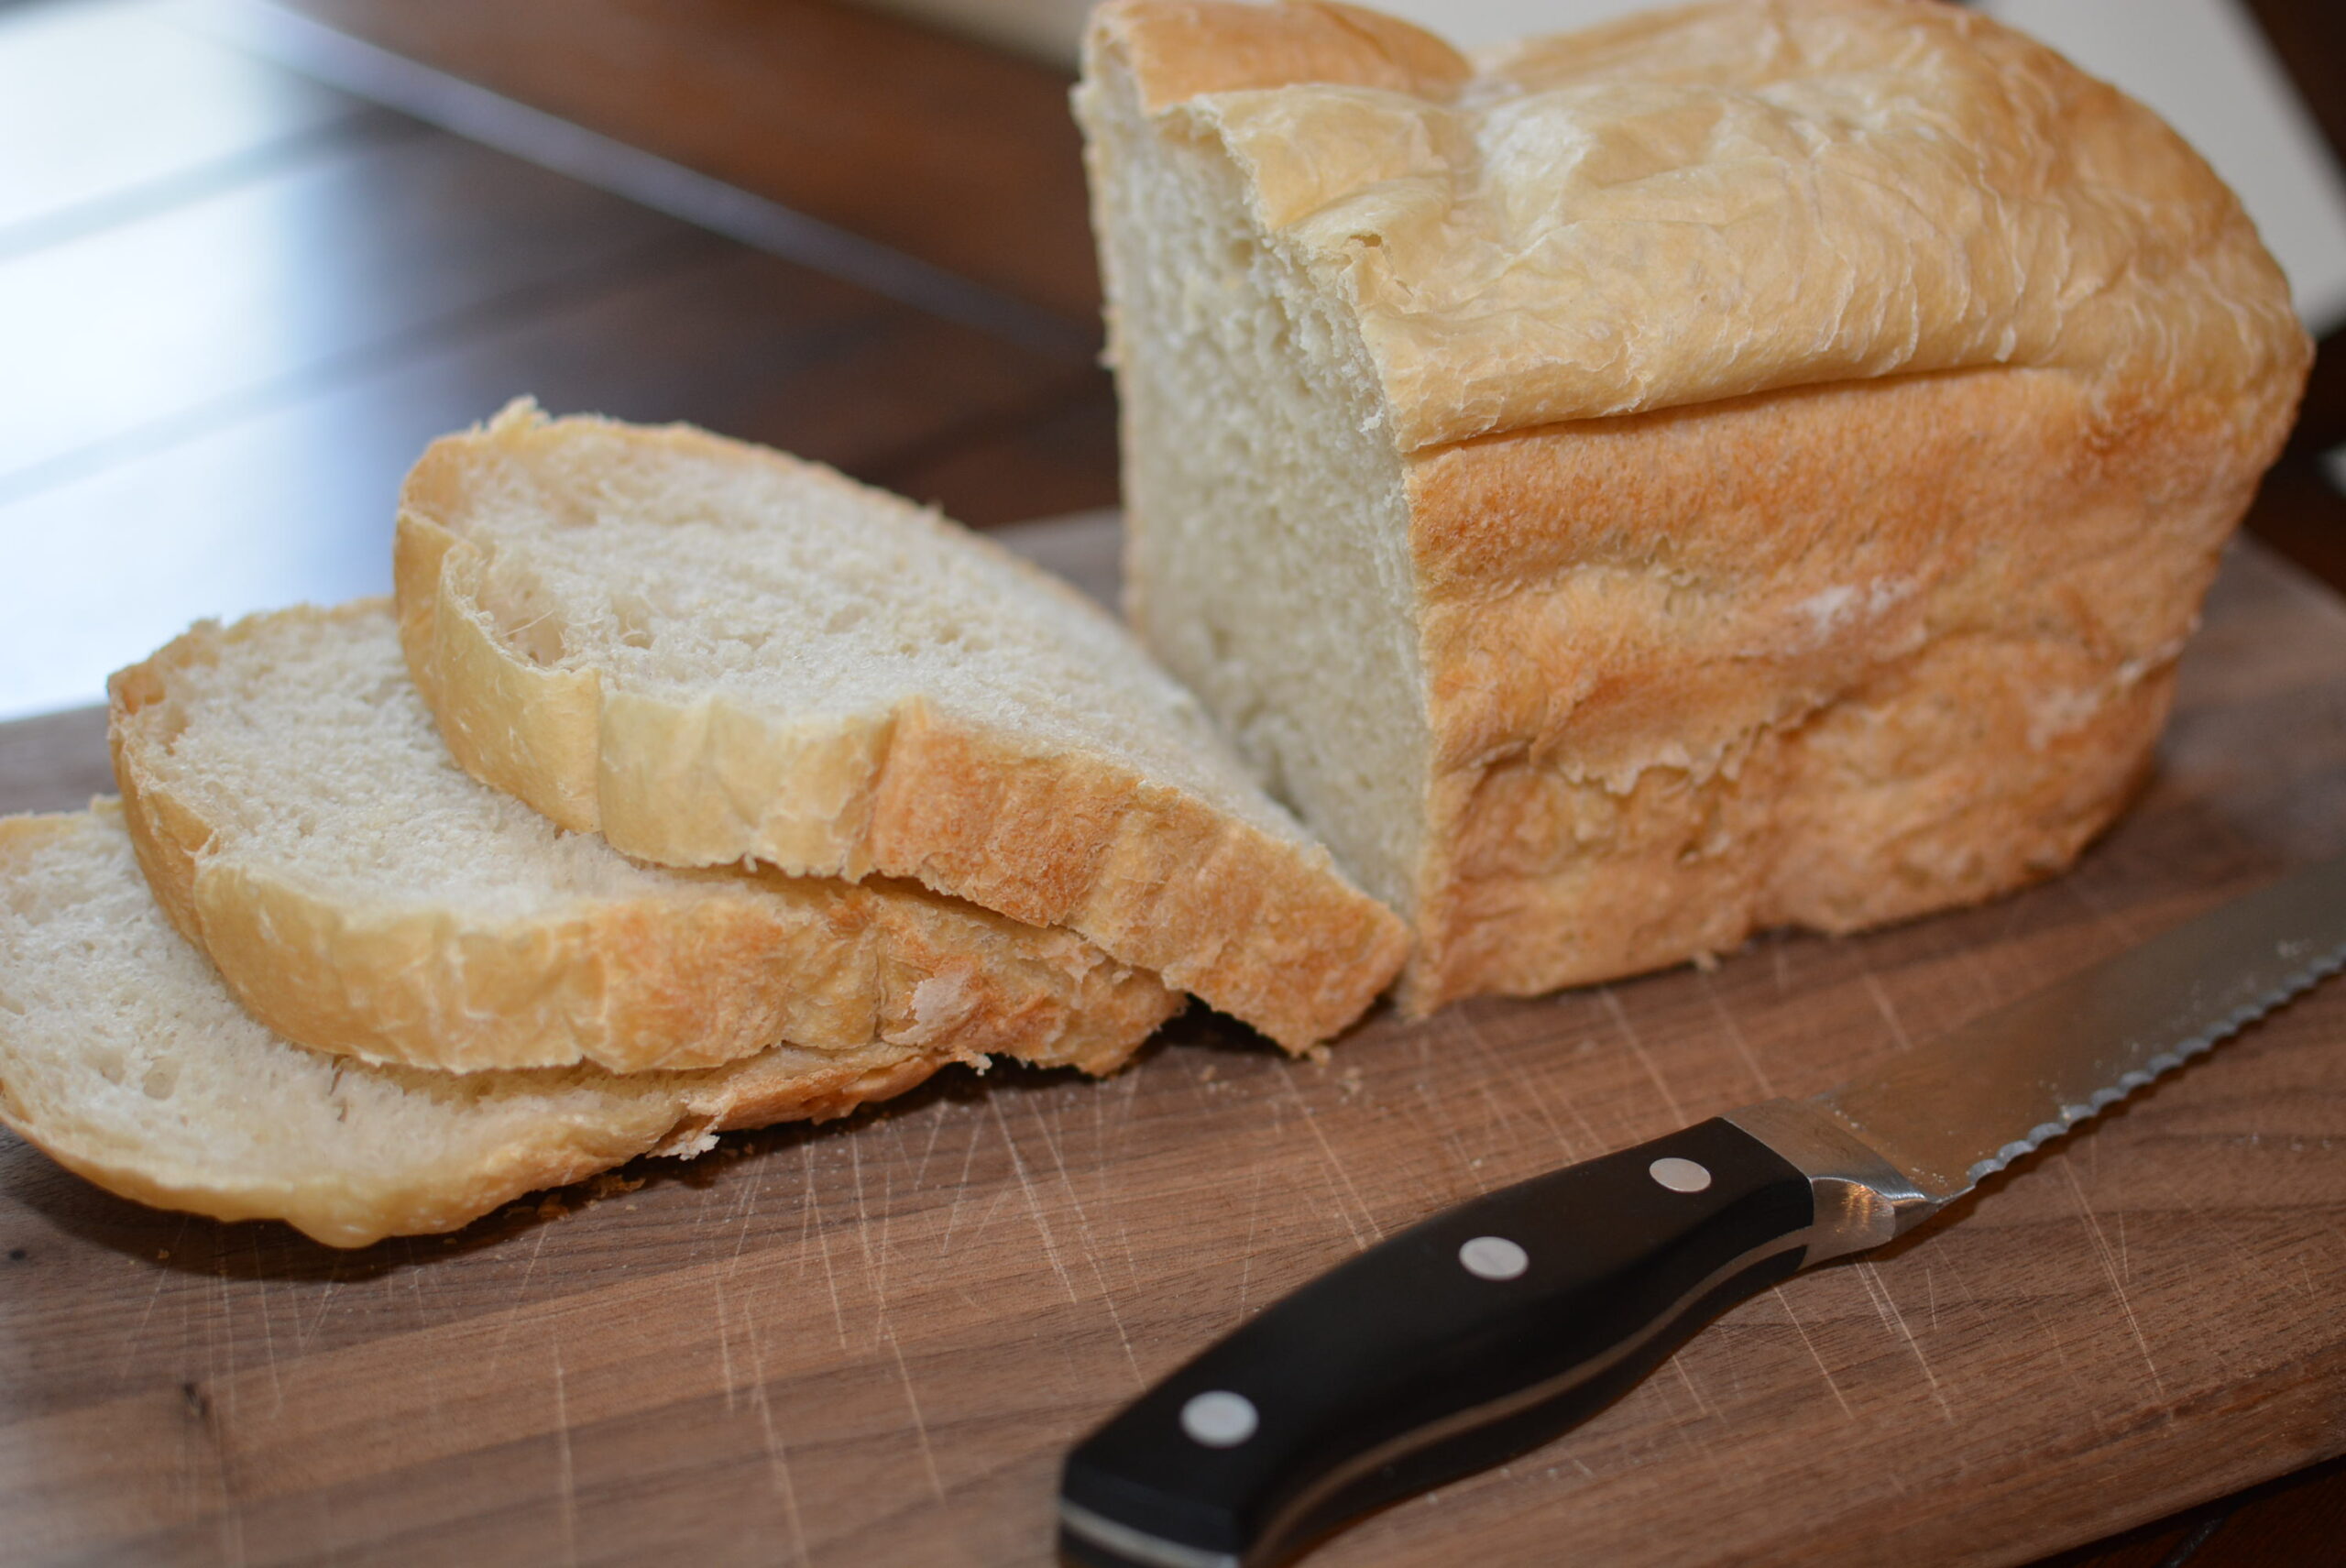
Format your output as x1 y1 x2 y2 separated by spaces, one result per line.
0 404 1408 1246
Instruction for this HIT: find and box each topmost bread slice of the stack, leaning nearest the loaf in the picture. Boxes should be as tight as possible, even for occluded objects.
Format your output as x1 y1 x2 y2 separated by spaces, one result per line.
397 404 1408 1049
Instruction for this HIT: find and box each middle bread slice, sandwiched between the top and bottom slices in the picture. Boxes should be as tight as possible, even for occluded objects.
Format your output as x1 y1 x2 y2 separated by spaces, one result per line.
110 601 1185 1073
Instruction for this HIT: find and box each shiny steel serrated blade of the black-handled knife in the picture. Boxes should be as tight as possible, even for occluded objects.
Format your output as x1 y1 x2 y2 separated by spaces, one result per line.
1811 857 2346 1207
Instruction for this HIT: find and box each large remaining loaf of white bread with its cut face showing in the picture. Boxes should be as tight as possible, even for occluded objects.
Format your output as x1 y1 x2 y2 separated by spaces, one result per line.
1077 0 2308 1009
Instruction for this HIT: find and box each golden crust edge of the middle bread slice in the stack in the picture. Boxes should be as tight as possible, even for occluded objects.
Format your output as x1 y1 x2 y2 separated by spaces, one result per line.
110 601 1182 1073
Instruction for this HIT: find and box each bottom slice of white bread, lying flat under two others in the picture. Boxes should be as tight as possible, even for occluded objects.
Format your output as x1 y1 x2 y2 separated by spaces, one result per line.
0 800 946 1246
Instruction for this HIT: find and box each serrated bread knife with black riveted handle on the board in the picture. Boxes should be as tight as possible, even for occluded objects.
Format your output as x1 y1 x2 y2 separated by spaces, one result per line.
1058 857 2346 1568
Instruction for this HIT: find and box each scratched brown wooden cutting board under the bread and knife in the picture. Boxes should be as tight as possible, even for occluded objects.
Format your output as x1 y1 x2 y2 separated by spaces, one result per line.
0 523 2346 1568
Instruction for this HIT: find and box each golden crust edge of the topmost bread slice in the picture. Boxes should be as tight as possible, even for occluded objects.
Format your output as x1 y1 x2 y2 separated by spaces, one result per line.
397 411 1408 1051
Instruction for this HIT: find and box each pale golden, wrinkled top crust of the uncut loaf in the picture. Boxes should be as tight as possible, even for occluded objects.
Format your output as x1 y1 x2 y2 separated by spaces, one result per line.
1086 0 2306 453
